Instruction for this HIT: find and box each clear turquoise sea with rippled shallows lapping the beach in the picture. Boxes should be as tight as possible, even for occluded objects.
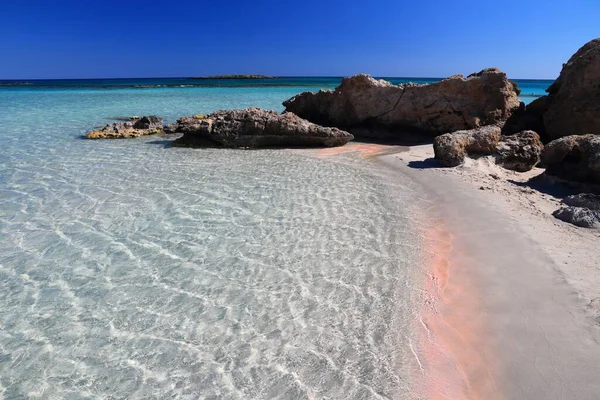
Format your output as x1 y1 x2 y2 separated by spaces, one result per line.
0 78 551 399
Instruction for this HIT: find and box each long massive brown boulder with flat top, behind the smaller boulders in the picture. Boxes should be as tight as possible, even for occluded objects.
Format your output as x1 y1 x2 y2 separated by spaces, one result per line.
283 68 520 137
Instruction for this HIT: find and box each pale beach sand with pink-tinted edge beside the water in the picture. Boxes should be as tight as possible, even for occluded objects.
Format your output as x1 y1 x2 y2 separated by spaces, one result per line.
377 145 600 400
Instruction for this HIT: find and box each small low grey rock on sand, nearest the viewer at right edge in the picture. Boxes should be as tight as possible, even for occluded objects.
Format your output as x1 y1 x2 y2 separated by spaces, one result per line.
552 193 600 228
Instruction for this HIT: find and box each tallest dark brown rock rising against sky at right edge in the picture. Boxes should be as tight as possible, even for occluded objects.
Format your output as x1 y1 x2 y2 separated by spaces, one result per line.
544 39 600 139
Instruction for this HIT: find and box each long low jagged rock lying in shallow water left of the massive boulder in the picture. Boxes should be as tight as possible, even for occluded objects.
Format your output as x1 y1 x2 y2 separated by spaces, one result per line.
167 108 353 148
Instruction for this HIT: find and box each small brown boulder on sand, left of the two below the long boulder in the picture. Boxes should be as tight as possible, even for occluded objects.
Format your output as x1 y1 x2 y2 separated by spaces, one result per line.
433 125 501 167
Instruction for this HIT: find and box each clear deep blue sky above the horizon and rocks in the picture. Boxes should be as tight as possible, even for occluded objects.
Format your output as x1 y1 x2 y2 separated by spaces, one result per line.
0 0 600 79
